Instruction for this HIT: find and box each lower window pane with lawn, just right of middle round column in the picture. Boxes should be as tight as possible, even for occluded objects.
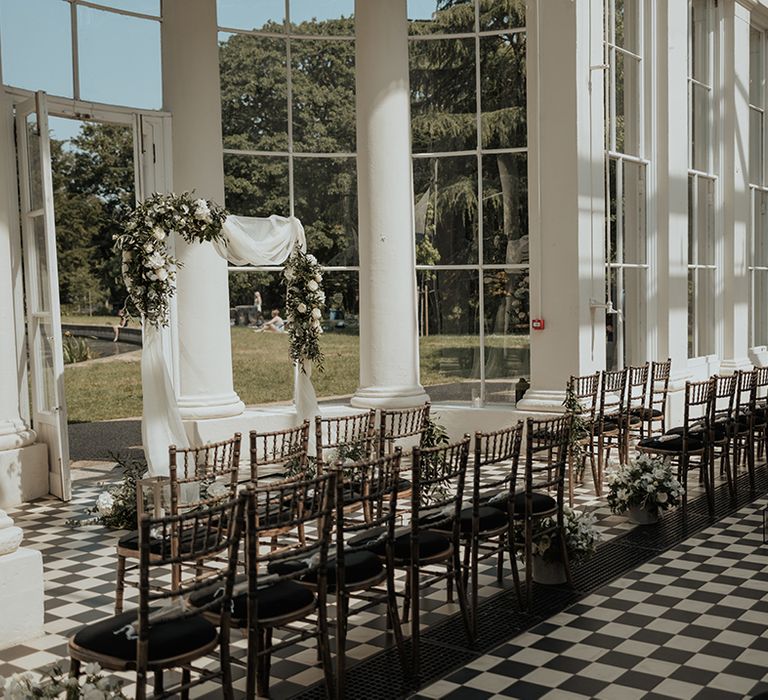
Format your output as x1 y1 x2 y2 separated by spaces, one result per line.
417 270 480 401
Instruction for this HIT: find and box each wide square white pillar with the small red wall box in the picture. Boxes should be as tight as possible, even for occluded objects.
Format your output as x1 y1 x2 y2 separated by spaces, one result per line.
517 0 605 412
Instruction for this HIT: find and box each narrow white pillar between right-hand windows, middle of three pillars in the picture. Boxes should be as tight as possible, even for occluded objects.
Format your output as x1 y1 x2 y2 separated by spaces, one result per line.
649 2 690 425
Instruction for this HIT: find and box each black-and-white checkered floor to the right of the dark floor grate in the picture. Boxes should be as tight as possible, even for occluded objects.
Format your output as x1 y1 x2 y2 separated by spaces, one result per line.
415 492 768 700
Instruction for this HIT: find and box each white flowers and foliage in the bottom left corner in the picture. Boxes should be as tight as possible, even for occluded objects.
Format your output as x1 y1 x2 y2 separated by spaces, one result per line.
0 662 128 700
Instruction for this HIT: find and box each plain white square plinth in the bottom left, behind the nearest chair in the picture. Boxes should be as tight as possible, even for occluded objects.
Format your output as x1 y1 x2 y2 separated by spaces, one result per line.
0 547 44 649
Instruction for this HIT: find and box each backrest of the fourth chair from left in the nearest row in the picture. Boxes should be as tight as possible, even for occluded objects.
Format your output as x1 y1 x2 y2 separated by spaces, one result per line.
411 435 471 535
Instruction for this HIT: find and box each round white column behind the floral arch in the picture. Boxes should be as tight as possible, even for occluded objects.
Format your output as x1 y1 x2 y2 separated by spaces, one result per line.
162 0 244 419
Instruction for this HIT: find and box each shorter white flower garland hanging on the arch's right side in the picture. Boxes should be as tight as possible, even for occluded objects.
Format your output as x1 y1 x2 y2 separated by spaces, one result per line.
283 248 325 372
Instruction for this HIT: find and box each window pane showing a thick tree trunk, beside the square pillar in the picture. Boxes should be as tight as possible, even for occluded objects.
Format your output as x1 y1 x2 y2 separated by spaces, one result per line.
483 153 528 265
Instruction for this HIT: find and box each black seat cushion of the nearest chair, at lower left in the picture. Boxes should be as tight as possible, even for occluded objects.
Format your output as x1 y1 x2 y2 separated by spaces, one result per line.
73 610 217 663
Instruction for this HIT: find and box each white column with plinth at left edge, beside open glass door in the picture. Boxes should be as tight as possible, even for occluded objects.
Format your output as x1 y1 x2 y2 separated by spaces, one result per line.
0 92 48 508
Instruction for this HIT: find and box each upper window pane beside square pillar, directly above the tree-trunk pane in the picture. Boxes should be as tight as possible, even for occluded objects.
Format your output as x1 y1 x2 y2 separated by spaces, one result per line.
480 32 526 148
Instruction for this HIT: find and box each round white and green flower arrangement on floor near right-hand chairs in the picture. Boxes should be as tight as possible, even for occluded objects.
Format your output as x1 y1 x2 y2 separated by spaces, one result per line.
608 454 684 525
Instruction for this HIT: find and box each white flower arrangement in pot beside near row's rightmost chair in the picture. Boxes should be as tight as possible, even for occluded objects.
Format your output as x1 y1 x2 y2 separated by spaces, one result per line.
518 506 600 584
